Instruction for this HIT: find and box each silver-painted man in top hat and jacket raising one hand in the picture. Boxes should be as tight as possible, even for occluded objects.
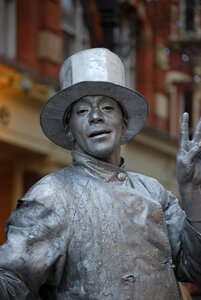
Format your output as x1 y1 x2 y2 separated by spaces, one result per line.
0 48 201 300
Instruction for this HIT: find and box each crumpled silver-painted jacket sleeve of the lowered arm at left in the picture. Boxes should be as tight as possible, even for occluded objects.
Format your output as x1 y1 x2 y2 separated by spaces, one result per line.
0 177 70 300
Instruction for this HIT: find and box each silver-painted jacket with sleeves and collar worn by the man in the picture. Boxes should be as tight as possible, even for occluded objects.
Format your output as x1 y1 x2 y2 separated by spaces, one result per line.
0 152 201 300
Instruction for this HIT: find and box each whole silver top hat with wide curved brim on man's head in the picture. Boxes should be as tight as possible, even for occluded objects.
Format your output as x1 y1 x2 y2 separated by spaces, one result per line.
40 48 147 150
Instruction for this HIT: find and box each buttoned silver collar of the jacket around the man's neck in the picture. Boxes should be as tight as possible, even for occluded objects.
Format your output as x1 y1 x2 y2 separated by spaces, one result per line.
72 151 127 181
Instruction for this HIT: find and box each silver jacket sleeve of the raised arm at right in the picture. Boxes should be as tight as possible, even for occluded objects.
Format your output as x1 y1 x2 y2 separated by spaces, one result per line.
164 191 201 285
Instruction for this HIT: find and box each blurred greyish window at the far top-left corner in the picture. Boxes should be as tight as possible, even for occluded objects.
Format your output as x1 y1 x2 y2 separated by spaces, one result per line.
0 0 16 59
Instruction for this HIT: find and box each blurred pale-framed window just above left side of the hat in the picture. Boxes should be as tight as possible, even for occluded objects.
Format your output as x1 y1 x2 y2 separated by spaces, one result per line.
61 0 90 59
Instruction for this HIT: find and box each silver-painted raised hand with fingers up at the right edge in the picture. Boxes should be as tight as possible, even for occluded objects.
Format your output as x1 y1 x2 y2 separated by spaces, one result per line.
177 113 201 185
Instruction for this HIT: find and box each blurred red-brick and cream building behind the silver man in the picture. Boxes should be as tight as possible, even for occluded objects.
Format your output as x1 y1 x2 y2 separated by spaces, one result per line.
0 0 201 243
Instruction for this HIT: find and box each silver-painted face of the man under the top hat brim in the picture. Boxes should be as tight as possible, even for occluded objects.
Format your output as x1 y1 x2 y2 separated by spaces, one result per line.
69 96 123 163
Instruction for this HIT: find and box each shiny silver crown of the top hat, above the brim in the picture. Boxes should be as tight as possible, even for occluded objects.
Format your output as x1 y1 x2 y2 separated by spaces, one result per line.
60 48 125 89
